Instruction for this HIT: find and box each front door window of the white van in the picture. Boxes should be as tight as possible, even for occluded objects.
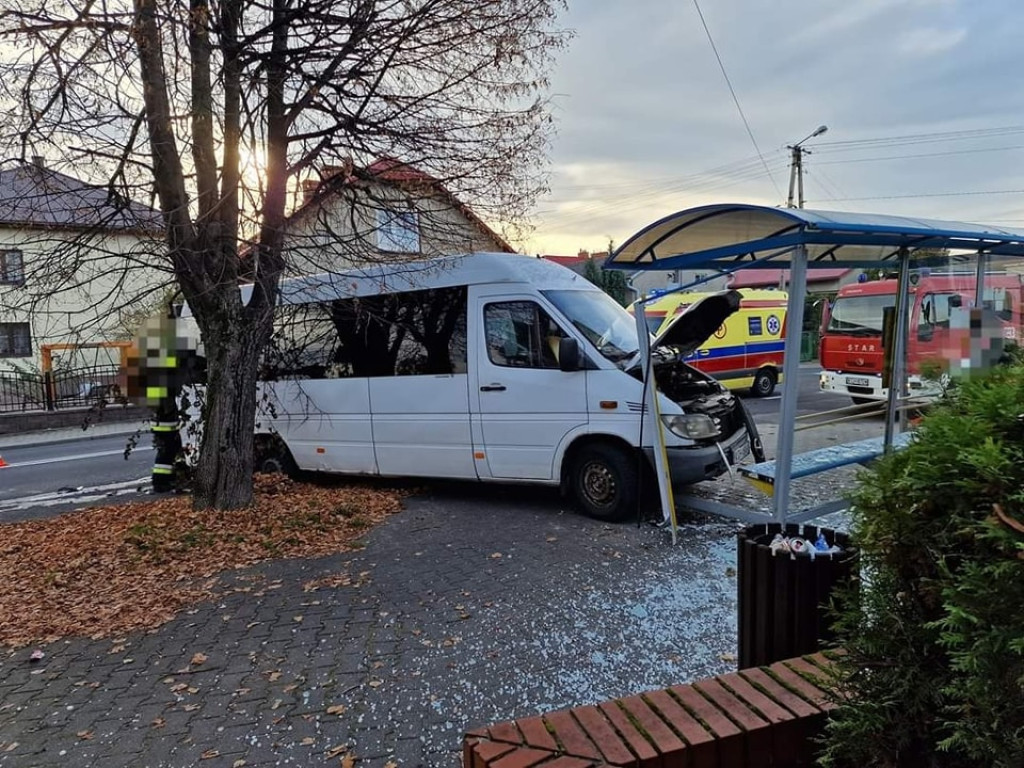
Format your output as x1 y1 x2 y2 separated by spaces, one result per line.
483 301 568 368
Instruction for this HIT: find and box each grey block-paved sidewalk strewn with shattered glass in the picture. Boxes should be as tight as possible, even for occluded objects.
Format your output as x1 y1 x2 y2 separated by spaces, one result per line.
0 485 737 768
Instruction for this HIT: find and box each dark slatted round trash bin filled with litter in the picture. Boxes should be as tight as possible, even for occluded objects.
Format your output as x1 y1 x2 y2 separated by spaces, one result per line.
736 523 858 669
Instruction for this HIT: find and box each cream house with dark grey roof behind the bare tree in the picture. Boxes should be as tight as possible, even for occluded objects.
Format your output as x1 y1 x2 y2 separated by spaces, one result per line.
0 158 162 371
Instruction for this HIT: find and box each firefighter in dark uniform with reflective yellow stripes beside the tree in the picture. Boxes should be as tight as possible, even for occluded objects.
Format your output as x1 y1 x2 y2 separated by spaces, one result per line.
128 313 189 493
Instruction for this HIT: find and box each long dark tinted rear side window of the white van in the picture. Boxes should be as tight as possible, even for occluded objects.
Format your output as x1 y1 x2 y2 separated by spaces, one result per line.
264 287 467 379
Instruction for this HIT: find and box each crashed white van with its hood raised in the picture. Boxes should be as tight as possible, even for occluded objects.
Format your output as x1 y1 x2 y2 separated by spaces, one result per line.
209 253 757 520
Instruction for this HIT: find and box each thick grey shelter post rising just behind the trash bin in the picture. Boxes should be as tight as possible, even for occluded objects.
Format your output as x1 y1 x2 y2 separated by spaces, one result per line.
772 244 807 523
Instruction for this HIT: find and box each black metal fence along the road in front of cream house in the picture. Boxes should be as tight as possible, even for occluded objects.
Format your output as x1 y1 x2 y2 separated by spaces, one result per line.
0 365 125 413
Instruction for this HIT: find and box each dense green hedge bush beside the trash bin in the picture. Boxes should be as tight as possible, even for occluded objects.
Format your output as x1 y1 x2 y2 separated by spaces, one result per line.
823 360 1024 768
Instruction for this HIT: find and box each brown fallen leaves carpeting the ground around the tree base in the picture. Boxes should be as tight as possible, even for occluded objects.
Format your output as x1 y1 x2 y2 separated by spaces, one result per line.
0 475 400 646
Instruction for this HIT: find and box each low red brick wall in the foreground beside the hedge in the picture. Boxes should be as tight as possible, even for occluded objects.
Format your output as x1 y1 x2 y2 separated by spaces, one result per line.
463 653 836 768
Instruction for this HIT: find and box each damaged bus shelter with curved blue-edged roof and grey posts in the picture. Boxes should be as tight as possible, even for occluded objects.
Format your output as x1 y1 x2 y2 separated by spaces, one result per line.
605 204 1024 538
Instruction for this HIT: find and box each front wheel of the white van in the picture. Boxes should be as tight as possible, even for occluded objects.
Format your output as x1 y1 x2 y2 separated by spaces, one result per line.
571 443 639 521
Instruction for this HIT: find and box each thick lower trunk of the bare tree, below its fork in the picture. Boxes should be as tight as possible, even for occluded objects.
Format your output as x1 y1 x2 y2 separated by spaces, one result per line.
193 307 264 510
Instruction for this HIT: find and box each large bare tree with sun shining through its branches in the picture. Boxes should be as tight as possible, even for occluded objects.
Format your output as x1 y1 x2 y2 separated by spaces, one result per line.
0 0 566 509
